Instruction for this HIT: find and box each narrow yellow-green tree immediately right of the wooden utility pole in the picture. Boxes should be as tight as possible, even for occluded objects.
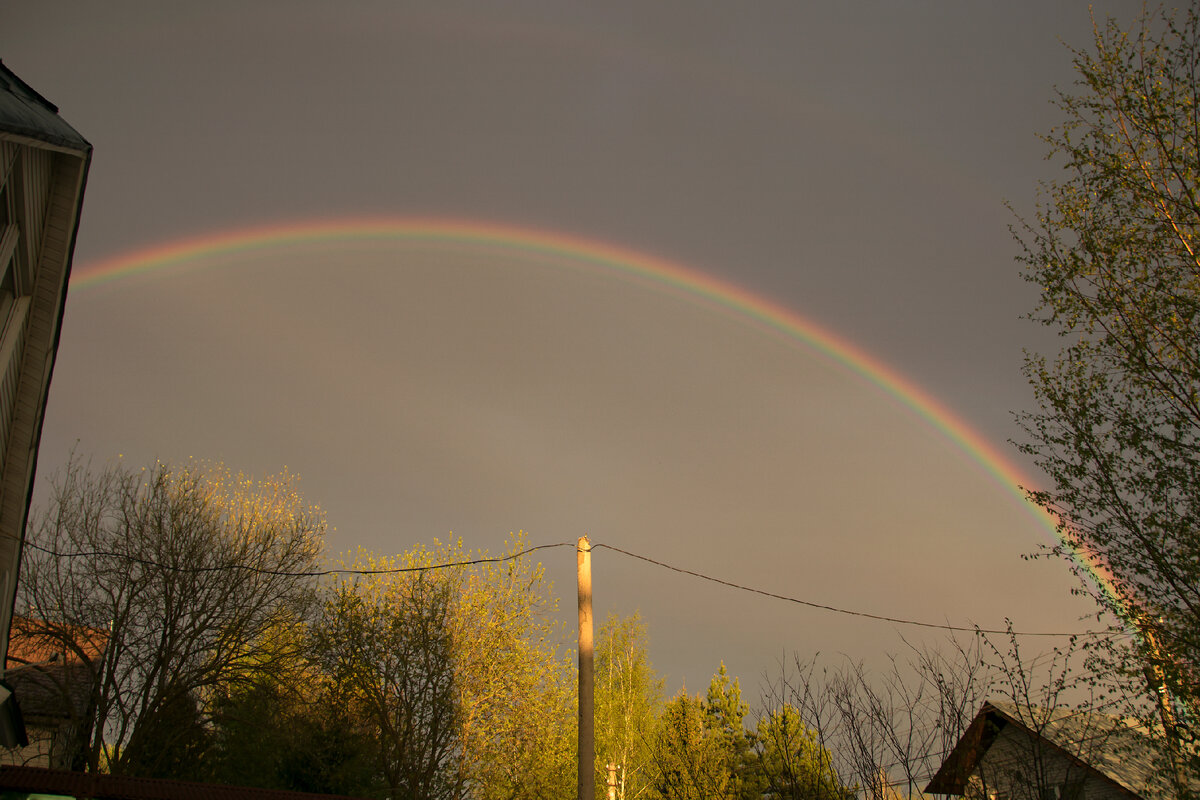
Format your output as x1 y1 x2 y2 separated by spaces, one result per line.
595 614 662 800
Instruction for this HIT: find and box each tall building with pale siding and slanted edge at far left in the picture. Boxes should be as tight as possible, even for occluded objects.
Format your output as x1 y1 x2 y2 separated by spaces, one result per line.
0 62 91 681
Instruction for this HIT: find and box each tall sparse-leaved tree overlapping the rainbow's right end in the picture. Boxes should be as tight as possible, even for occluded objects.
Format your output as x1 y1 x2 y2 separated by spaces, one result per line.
1018 4 1200 792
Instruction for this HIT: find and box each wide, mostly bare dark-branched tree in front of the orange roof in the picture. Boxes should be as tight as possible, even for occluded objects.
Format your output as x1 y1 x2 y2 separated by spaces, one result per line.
13 459 325 776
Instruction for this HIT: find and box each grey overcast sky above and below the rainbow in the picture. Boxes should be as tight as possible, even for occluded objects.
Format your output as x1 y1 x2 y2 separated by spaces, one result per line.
0 0 1138 691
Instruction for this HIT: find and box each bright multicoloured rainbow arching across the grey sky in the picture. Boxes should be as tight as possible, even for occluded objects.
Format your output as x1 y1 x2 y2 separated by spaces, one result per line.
71 217 1128 608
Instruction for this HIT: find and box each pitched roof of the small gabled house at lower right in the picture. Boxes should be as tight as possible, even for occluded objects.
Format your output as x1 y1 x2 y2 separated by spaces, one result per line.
925 703 1170 798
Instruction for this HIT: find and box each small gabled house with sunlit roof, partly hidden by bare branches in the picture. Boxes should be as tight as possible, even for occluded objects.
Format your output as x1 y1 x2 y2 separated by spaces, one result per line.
925 703 1174 800
